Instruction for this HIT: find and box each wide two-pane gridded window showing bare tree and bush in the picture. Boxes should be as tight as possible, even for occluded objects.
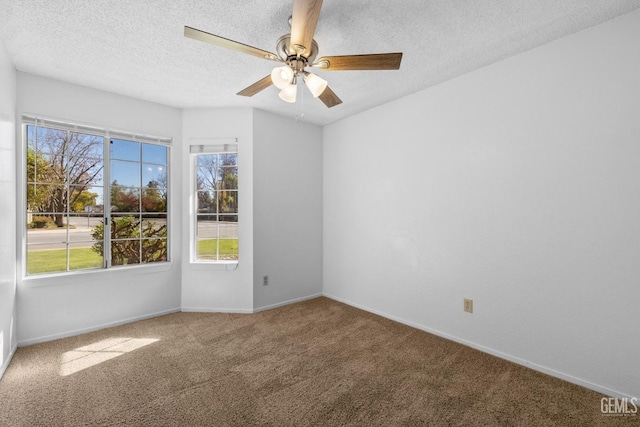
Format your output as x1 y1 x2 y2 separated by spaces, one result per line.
25 120 169 275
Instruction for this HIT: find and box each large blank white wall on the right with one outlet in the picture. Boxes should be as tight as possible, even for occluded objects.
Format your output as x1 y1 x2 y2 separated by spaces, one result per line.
323 11 640 397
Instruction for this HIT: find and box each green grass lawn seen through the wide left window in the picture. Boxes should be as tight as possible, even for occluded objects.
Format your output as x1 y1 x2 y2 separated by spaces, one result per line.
27 248 103 274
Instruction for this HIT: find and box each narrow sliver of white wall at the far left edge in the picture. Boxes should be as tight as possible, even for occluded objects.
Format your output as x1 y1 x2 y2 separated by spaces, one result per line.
0 43 17 377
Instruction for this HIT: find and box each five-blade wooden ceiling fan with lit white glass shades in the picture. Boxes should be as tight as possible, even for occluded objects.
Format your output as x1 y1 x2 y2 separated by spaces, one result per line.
184 0 402 108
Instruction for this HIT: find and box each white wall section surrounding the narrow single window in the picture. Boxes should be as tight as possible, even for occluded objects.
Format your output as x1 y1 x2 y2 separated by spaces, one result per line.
181 108 253 313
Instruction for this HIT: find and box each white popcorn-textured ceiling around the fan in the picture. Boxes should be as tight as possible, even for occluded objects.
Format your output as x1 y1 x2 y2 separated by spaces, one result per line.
0 0 640 125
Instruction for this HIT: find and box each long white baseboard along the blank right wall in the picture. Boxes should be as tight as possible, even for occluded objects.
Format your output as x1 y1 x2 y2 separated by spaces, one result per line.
323 293 636 399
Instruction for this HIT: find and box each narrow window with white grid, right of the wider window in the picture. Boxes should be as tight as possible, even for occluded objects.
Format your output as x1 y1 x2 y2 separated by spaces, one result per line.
191 143 238 262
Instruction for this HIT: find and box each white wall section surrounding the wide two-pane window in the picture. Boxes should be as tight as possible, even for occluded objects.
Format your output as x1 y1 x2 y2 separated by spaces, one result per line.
16 72 182 344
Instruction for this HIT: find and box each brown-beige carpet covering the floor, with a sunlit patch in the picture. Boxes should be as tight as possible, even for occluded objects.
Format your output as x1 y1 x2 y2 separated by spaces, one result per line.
0 298 640 426
